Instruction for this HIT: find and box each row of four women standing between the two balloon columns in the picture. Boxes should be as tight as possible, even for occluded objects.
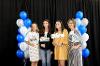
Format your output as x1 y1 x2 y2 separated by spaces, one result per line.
25 19 82 66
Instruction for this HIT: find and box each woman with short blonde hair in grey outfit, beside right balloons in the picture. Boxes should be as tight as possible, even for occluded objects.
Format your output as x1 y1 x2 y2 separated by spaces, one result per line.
68 19 83 66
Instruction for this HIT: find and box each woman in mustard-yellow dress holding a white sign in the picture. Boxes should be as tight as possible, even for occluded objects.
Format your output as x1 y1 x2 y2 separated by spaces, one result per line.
53 20 68 66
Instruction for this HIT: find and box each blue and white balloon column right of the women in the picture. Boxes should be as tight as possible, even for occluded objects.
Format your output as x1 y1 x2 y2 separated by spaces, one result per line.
75 11 90 58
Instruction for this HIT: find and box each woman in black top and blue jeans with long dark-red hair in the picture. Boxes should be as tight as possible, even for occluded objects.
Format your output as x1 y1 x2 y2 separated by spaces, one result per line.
40 19 52 66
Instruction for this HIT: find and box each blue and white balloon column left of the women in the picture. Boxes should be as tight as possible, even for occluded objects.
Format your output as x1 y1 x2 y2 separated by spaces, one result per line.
16 11 32 59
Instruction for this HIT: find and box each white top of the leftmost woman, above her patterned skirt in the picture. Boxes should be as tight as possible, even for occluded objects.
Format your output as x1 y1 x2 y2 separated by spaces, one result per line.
25 32 39 44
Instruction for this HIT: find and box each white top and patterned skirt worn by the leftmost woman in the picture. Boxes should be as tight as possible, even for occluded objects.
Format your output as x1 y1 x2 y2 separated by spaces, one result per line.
25 32 39 62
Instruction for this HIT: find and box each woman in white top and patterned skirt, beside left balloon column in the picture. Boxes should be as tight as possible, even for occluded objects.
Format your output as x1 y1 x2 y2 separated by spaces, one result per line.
25 23 39 66
